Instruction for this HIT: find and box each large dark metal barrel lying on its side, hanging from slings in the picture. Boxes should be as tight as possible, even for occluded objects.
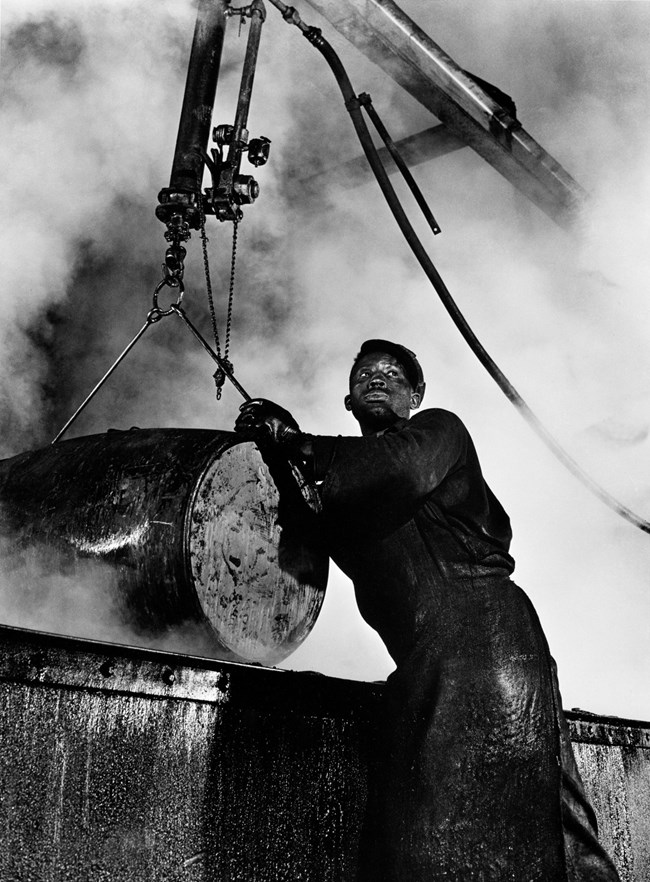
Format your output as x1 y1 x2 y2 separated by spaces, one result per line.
0 429 328 664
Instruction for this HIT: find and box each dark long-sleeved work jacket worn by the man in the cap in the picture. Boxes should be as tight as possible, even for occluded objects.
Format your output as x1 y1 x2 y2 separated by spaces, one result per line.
314 410 514 662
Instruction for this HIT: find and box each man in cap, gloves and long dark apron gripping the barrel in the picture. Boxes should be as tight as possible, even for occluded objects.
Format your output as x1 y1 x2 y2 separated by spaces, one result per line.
235 340 618 882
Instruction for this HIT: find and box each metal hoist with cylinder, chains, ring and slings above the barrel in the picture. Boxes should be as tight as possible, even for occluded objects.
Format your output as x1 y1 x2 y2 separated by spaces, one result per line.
52 0 271 444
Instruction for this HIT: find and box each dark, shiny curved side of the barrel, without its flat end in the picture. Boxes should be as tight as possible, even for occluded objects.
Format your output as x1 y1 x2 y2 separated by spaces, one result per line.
0 429 231 634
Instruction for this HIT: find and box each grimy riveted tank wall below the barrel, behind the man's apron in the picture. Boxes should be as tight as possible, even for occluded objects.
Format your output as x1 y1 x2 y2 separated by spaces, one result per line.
0 628 650 882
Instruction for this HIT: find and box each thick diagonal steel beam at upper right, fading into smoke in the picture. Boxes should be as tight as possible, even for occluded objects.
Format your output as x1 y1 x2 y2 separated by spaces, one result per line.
307 0 587 226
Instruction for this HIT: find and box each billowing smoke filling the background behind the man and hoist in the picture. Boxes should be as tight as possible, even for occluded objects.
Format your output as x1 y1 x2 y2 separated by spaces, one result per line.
0 0 650 719
